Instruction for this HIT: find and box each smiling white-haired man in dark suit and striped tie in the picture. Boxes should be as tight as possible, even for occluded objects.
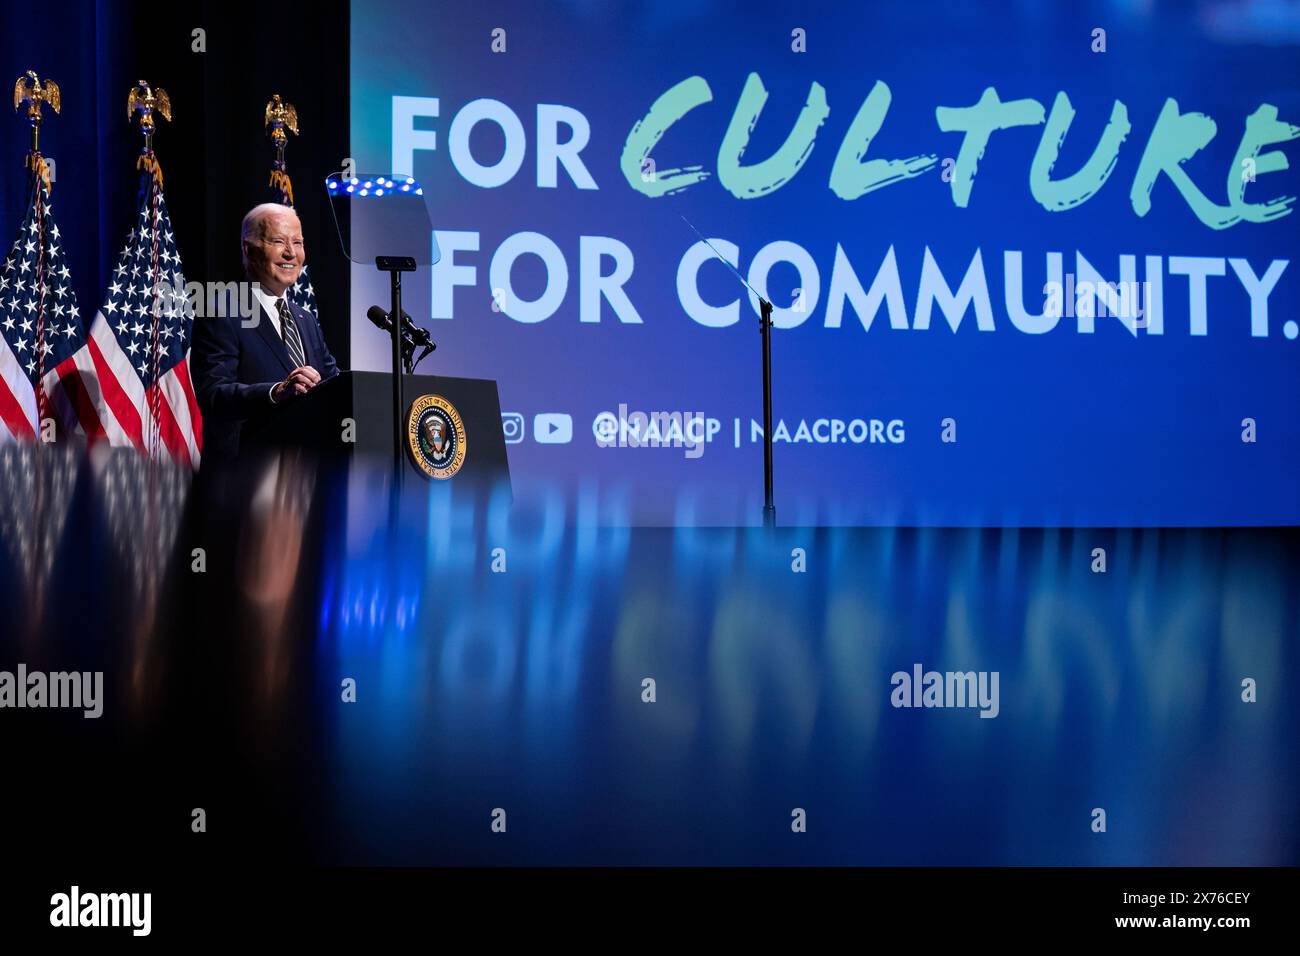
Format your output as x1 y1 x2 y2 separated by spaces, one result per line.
190 203 338 462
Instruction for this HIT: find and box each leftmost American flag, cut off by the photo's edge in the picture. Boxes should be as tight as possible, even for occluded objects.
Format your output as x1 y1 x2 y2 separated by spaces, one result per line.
0 177 101 442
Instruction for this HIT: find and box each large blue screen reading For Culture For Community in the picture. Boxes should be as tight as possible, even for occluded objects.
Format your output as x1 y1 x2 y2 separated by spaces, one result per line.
348 0 1300 525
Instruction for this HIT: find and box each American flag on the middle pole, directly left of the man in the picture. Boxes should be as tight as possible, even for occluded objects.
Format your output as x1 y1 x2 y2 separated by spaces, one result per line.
83 172 203 468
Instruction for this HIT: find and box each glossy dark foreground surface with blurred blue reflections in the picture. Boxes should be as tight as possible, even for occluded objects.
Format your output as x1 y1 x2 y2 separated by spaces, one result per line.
0 449 1300 866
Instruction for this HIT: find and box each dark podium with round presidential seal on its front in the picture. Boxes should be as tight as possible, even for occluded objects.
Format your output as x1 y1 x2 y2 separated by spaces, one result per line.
239 372 510 484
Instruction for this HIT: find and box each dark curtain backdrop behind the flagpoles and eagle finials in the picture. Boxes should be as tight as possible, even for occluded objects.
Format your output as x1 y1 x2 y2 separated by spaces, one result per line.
0 0 350 367
